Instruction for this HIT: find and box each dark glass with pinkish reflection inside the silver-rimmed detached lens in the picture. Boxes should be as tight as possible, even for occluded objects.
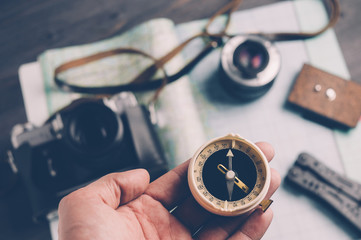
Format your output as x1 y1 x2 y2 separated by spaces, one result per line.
233 40 269 78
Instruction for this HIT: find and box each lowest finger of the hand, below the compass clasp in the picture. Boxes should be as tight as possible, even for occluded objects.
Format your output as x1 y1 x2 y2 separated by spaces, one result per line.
229 209 273 240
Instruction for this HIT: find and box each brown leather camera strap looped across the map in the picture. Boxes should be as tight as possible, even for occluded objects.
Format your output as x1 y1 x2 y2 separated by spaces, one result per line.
54 0 340 102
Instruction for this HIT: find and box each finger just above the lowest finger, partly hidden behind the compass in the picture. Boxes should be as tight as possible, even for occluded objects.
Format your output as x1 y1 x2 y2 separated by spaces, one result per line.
193 169 281 239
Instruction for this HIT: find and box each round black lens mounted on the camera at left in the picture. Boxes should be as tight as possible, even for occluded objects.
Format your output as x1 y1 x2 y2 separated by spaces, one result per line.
68 102 123 154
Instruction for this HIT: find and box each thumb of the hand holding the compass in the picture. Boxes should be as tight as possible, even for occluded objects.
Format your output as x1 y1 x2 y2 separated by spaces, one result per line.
80 169 149 209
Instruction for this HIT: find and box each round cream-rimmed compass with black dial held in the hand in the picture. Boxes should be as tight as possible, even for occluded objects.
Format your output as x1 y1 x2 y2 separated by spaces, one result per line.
188 134 272 216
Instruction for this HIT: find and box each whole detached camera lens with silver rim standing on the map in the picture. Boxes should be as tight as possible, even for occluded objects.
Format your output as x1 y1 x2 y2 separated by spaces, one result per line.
221 35 281 101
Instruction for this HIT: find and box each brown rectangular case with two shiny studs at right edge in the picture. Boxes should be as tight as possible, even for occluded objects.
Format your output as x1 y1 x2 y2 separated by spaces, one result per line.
288 64 361 128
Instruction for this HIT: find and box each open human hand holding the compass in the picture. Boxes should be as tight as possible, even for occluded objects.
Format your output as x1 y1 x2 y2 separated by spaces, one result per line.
58 143 280 240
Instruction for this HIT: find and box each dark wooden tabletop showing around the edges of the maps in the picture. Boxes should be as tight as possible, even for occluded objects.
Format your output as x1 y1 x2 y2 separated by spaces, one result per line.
0 0 361 240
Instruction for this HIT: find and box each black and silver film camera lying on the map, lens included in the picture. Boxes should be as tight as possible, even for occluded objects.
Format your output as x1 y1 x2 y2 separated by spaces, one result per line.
11 92 168 219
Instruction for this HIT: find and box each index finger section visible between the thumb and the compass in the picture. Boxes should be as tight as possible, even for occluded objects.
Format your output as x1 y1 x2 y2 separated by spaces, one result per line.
145 160 190 210
